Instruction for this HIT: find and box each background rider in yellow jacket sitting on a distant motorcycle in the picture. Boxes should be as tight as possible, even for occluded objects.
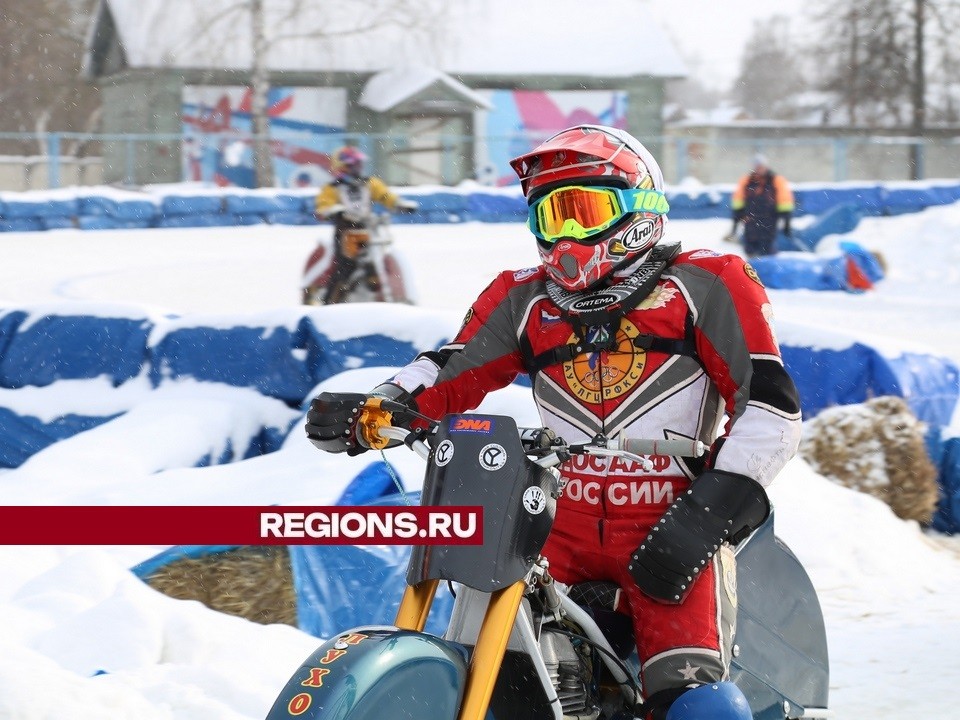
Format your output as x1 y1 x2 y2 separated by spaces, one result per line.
316 145 417 305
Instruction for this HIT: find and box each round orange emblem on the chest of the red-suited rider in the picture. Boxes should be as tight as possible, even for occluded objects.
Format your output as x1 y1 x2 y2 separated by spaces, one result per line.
563 319 647 405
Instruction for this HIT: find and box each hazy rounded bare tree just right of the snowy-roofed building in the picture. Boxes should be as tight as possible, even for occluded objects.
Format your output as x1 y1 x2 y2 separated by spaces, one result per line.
731 16 807 120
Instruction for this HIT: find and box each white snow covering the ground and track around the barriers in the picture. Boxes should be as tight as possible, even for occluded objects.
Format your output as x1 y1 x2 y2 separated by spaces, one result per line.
0 205 960 720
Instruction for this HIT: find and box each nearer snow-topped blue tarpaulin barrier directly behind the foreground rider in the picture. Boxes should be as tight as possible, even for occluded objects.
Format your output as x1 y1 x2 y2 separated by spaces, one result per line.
0 303 960 528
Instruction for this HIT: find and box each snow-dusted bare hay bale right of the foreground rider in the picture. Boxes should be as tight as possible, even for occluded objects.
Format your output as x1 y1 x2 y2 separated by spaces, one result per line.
800 396 940 525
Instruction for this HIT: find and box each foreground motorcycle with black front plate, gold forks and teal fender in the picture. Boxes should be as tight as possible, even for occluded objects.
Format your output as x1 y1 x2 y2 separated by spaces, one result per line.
267 399 830 720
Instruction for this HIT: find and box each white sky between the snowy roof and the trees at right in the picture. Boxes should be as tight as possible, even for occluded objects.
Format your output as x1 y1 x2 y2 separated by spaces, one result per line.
645 0 810 90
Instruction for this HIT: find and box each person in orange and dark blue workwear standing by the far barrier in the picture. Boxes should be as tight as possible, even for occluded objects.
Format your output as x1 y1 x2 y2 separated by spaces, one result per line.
727 155 794 257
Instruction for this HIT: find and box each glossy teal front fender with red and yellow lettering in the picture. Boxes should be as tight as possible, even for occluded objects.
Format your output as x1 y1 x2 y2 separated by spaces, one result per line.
267 626 467 720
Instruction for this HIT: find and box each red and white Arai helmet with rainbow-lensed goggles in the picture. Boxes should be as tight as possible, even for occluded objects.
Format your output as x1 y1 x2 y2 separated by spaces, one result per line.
510 125 669 291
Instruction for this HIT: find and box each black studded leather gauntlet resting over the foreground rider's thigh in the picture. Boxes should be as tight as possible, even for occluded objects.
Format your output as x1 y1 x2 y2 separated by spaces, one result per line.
627 470 770 604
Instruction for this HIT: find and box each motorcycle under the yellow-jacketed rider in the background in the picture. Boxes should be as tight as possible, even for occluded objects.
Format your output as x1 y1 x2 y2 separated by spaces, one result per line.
301 213 412 305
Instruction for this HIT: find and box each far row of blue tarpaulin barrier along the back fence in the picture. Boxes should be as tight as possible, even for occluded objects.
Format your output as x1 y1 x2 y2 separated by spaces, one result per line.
7 182 960 232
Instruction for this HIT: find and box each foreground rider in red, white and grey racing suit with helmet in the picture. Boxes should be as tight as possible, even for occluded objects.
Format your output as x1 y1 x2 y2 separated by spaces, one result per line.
306 125 801 720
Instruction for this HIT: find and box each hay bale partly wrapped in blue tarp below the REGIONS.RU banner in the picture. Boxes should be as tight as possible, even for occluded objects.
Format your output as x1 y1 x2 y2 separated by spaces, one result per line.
145 545 297 627
